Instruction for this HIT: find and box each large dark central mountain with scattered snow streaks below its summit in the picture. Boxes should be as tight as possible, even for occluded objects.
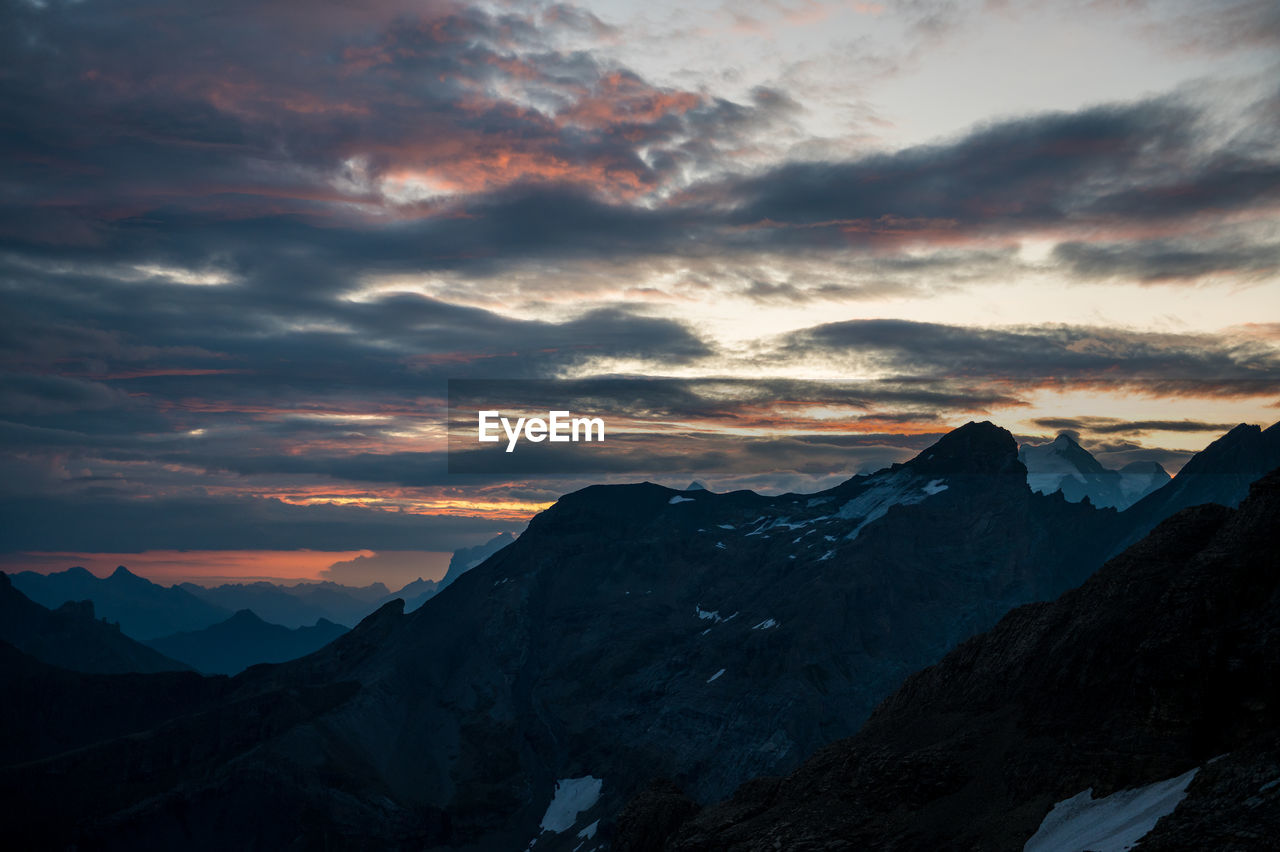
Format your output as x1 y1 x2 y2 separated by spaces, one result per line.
0 423 1126 851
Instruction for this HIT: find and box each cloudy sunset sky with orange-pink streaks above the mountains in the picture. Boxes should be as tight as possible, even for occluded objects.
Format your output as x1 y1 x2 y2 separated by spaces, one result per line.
0 0 1280 585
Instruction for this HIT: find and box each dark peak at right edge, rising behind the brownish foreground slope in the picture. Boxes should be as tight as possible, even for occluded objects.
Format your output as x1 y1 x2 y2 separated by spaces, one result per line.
1120 423 1280 548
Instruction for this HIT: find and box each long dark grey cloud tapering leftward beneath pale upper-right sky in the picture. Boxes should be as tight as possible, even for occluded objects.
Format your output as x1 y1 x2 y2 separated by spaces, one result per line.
691 99 1280 243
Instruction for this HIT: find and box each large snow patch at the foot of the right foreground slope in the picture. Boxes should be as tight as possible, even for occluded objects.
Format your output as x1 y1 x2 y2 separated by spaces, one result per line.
1023 768 1199 852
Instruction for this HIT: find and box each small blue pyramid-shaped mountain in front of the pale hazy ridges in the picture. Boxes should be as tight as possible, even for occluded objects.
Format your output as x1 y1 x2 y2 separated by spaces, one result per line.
147 609 347 674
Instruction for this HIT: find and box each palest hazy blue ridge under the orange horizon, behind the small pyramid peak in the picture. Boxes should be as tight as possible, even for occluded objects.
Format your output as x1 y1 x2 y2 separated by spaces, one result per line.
179 581 388 628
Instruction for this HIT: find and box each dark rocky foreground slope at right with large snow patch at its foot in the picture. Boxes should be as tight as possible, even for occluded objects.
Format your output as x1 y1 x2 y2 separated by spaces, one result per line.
624 471 1280 852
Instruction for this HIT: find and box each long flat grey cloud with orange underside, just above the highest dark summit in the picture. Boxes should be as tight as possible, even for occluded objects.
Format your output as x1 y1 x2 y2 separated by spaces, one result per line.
778 320 1280 397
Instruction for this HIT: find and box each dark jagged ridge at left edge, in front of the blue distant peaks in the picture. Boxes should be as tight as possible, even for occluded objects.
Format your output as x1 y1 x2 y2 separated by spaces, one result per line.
0 572 188 674
